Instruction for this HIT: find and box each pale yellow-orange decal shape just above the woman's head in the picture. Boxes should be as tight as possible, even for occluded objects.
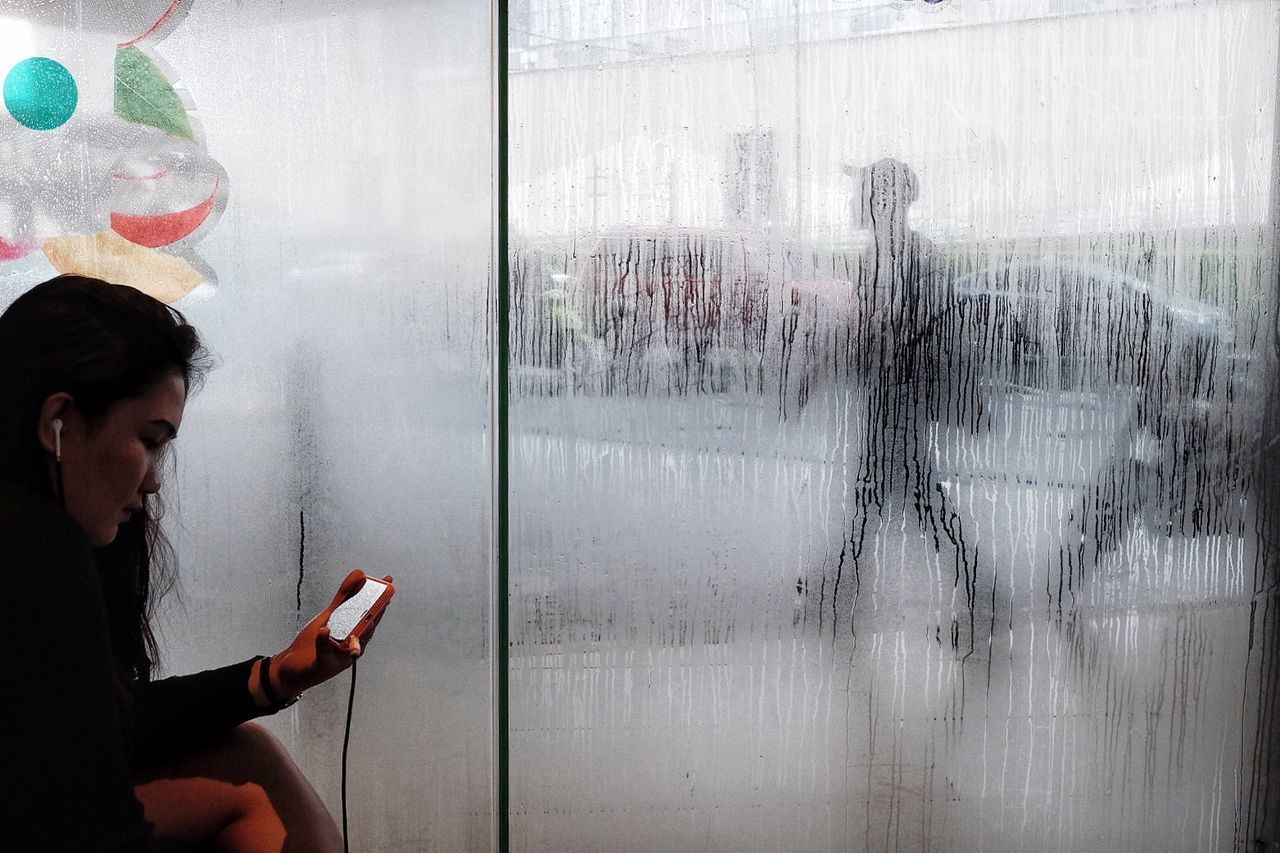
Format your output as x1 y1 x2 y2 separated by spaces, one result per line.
45 231 205 304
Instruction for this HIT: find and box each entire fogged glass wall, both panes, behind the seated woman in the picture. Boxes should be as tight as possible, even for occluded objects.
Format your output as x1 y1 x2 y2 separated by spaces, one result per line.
0 0 1280 852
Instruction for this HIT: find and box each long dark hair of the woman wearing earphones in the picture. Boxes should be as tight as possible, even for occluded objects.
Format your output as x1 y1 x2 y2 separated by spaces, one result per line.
0 275 209 679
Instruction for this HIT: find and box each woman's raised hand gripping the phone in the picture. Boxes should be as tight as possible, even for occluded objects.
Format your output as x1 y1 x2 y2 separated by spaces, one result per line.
252 569 392 707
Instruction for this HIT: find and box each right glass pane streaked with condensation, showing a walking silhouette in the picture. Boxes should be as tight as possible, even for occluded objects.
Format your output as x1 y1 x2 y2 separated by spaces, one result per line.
508 0 1280 850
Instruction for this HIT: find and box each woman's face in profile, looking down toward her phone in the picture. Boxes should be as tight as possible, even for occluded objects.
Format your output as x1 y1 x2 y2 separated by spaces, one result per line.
61 371 187 547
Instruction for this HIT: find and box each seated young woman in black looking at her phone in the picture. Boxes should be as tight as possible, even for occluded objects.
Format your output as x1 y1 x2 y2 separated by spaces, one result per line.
0 275 389 852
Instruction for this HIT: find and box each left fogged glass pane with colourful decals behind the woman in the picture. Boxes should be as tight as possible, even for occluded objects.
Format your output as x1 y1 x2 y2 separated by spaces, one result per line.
0 0 493 850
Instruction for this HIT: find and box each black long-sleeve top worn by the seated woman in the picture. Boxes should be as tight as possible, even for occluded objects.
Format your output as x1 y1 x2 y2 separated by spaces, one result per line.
0 484 272 850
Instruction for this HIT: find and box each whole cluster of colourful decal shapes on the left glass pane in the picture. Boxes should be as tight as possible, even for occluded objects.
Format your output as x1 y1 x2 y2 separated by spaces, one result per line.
0 0 228 301
